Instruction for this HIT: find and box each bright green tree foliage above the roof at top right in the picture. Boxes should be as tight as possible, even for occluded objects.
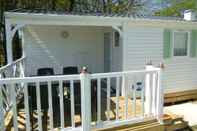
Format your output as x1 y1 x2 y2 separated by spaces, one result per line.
155 0 197 17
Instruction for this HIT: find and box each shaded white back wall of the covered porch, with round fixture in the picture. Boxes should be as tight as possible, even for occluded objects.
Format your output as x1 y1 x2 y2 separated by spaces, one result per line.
24 26 104 75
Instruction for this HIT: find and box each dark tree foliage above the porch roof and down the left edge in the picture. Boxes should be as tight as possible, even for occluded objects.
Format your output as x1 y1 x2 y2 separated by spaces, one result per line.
0 0 144 66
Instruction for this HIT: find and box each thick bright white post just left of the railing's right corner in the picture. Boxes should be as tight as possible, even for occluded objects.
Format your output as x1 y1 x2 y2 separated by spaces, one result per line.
145 64 154 115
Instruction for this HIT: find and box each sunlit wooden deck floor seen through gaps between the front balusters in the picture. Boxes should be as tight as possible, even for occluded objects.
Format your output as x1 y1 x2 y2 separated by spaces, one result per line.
5 97 142 131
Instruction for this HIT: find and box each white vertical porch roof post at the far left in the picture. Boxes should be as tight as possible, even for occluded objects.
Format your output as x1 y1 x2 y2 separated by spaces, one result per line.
5 20 13 64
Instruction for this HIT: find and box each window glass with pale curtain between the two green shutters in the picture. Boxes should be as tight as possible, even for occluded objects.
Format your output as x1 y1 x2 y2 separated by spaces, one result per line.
173 31 189 56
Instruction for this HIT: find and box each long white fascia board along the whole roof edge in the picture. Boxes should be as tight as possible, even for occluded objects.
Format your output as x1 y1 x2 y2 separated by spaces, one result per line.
5 12 197 29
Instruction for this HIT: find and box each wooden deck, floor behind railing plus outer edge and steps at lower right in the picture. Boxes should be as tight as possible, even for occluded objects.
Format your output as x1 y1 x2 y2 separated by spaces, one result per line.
5 96 196 131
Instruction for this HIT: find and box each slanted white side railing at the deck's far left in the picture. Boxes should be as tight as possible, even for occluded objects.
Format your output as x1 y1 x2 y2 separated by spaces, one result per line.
0 57 25 114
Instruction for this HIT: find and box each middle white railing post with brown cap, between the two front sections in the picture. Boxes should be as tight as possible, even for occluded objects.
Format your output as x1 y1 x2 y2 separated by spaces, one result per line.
80 68 91 131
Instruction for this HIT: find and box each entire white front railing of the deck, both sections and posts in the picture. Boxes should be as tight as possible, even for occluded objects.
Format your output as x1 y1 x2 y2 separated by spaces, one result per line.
0 65 163 131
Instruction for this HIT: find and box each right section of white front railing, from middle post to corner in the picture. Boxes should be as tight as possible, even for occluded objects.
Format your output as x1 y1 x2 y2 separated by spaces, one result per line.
89 66 163 129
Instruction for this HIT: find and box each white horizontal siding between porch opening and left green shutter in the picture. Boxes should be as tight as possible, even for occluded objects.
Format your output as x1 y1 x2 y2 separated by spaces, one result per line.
123 27 163 70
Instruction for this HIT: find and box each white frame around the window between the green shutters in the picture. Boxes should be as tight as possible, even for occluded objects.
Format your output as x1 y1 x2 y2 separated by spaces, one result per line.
172 30 191 58
